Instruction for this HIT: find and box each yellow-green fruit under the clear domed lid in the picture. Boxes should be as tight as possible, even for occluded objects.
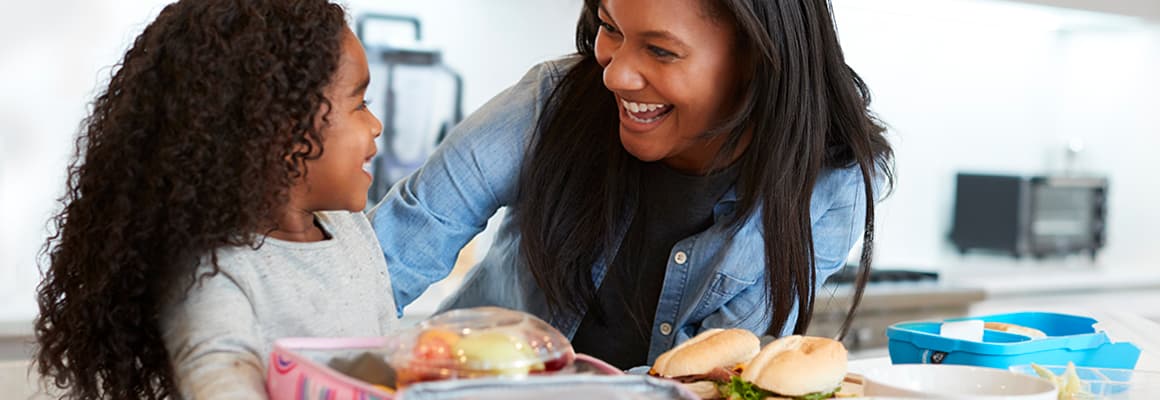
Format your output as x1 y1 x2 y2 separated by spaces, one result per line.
451 330 544 376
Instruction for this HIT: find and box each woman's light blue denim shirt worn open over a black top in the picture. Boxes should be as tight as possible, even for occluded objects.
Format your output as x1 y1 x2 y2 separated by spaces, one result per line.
372 59 877 363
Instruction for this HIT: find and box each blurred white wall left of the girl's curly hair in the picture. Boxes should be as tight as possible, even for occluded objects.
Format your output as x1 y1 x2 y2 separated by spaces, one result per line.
0 0 175 321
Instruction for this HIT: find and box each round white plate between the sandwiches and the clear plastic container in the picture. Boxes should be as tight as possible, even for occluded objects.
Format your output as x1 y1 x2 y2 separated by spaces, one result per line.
862 364 1057 400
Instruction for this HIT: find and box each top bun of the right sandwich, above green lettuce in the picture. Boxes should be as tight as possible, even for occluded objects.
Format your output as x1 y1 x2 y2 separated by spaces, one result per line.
741 335 846 397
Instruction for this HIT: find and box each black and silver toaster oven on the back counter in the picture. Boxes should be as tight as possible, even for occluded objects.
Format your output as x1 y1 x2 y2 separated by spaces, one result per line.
950 173 1108 260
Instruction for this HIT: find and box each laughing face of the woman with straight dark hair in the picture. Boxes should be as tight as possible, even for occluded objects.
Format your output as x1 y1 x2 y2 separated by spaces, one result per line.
595 0 741 173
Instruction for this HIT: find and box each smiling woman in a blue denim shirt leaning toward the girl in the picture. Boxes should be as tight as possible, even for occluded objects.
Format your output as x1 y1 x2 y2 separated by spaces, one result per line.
372 0 892 368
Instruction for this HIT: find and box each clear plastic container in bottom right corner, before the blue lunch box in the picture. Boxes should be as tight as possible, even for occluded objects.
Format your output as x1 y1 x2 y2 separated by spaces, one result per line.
1010 364 1160 400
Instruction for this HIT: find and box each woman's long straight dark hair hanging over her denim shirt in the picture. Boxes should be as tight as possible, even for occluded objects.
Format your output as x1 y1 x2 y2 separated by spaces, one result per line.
519 0 893 336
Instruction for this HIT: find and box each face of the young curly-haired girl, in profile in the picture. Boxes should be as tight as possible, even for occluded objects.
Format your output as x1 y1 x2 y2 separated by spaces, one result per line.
302 29 383 211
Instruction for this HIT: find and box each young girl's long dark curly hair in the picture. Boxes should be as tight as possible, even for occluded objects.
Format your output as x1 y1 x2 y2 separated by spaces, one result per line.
35 0 346 399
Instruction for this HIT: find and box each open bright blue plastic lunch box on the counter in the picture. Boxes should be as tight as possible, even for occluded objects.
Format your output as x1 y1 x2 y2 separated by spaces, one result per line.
886 312 1140 369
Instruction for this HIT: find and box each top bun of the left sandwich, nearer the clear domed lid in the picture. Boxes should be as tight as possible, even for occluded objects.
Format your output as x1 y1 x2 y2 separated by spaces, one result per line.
652 329 761 378
